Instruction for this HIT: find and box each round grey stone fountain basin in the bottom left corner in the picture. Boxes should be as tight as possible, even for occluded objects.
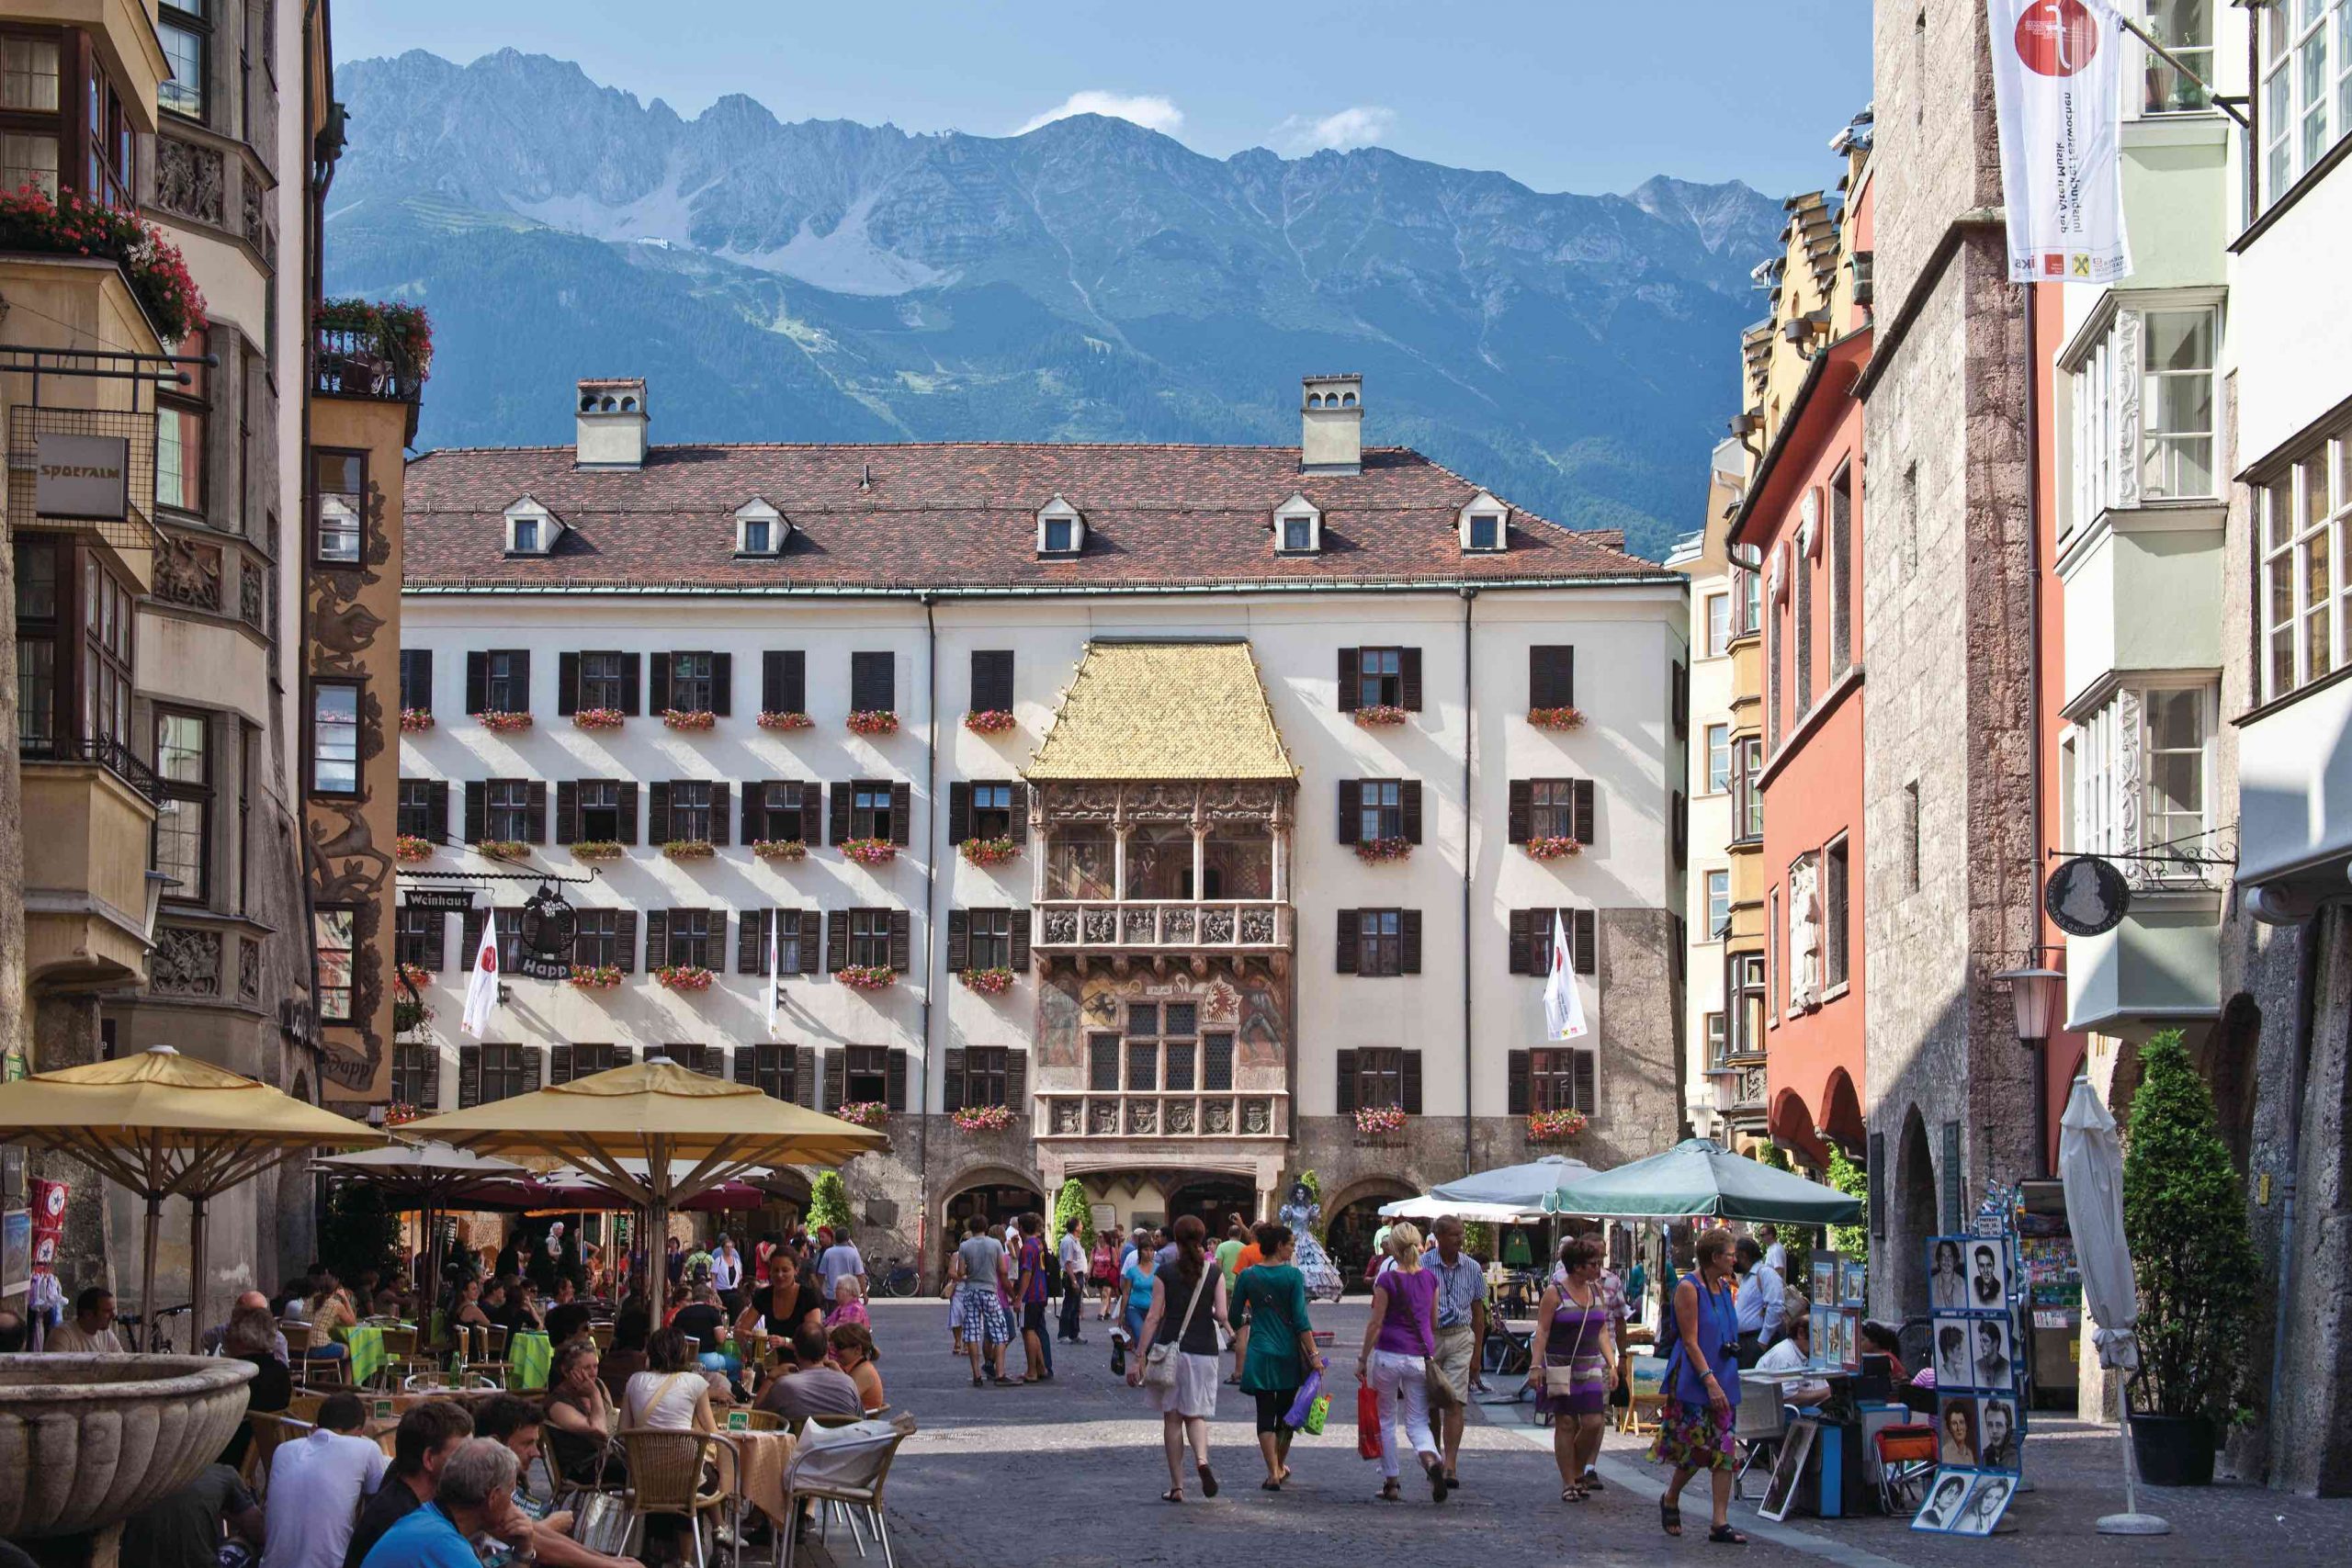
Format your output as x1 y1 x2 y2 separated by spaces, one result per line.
0 1357 256 1540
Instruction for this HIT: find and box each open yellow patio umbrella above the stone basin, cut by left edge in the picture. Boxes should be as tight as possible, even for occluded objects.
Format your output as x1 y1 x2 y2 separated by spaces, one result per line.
0 1046 383 1324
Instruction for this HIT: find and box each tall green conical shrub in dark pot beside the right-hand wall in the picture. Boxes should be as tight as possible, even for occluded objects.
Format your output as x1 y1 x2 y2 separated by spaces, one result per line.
2124 1030 2263 1485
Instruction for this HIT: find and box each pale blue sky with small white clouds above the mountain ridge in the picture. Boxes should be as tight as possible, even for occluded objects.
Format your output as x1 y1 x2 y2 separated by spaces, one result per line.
334 0 1870 195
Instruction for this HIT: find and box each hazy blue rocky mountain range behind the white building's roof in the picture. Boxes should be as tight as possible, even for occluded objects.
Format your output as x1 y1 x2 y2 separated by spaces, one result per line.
327 50 1782 555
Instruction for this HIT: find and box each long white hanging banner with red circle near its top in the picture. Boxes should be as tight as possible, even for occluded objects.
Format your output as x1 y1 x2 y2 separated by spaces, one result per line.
1985 0 2131 285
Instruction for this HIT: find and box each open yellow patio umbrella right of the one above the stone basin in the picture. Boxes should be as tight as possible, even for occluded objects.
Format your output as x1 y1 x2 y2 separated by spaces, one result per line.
400 1055 889 1283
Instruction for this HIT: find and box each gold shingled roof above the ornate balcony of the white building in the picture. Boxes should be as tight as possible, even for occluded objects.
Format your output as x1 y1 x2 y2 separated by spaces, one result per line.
1028 642 1298 781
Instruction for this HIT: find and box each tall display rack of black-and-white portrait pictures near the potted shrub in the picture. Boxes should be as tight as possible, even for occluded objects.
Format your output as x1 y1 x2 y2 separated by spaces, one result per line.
1912 1203 2030 1535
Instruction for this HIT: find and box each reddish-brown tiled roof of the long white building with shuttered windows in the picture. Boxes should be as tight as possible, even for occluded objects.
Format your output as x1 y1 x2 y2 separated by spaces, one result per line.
404 442 1677 590
